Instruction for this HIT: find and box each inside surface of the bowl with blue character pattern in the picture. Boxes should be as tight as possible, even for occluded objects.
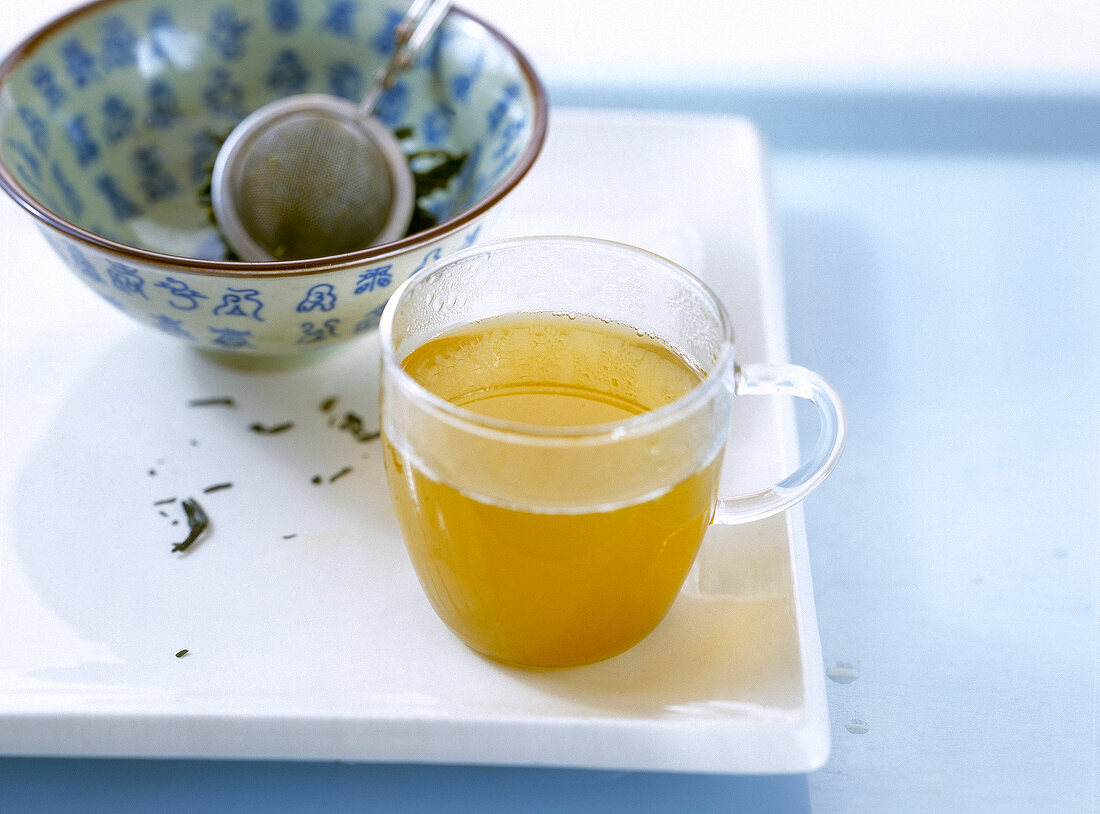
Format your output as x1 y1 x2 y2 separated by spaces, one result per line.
0 0 538 260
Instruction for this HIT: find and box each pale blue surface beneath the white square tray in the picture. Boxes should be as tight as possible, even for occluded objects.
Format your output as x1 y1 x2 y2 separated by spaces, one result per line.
0 86 1100 814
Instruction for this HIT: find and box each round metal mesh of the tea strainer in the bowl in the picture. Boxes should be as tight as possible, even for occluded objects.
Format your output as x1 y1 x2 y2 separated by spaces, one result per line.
232 113 394 260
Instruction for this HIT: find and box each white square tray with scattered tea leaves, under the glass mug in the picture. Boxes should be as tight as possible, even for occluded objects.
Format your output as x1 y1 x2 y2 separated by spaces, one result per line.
0 110 828 773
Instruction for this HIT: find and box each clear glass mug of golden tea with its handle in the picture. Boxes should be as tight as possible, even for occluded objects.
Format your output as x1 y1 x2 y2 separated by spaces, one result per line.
380 237 845 667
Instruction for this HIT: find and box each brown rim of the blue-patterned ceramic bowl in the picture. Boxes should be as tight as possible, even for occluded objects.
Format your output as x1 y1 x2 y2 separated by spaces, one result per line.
0 0 549 277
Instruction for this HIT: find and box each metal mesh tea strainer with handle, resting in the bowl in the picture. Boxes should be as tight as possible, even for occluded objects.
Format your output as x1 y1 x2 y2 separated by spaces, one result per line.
210 0 452 261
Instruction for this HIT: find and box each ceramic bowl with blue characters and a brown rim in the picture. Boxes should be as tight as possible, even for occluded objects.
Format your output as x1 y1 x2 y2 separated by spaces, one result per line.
0 0 547 359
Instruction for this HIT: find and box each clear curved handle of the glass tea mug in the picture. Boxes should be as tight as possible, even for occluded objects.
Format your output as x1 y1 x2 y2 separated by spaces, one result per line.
712 363 847 525
